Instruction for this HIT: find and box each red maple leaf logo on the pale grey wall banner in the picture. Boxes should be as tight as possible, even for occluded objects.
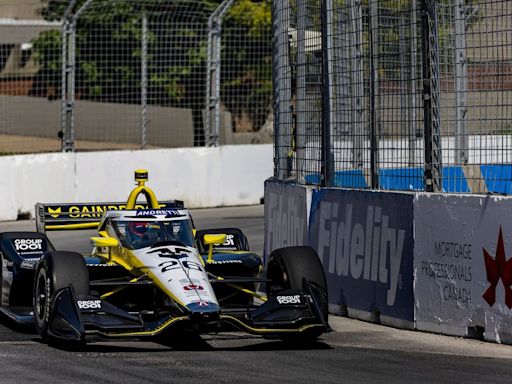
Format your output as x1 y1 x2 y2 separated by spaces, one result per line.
483 227 512 309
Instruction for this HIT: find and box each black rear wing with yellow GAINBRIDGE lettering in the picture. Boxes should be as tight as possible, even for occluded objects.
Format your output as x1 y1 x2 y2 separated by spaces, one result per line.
35 200 185 233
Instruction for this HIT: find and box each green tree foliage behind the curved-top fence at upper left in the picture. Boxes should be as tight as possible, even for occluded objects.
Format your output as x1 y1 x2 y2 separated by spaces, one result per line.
34 0 272 135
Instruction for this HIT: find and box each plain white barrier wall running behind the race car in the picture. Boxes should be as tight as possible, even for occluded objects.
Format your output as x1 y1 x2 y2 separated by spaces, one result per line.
0 144 273 220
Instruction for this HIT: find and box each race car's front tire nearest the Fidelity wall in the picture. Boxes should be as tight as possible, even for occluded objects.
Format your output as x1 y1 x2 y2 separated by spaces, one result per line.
267 247 329 339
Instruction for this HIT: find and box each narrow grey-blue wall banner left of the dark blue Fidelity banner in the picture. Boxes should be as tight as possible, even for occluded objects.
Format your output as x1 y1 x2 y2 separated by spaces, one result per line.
264 179 309 260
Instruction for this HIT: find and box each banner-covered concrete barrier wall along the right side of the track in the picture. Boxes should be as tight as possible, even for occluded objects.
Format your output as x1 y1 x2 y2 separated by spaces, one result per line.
265 180 512 344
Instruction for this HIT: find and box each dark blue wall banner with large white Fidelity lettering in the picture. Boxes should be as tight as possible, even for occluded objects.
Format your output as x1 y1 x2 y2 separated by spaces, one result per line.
310 189 414 321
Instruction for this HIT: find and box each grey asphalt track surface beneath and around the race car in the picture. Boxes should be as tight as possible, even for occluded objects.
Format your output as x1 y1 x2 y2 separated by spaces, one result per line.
0 206 512 384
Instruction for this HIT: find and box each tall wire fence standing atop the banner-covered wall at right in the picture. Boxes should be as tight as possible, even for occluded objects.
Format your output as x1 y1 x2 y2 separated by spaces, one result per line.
273 0 512 193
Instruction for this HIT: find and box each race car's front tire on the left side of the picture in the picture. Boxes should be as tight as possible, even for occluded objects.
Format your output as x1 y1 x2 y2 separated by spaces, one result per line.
33 251 89 341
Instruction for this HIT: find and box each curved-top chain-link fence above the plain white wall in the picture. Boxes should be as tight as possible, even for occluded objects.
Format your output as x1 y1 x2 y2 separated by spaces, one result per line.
0 0 273 153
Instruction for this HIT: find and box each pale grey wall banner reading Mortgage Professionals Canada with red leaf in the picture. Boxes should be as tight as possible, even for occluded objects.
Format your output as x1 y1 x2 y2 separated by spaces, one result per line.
414 194 512 342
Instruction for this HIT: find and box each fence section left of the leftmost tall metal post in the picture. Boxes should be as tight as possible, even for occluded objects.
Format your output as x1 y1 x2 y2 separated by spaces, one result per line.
0 19 61 153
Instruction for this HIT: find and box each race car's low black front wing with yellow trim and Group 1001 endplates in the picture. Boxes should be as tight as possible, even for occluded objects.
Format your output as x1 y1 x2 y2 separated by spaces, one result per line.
48 287 330 342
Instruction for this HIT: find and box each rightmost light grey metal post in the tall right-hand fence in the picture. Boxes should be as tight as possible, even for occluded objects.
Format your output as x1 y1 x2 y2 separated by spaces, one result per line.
455 0 469 164
